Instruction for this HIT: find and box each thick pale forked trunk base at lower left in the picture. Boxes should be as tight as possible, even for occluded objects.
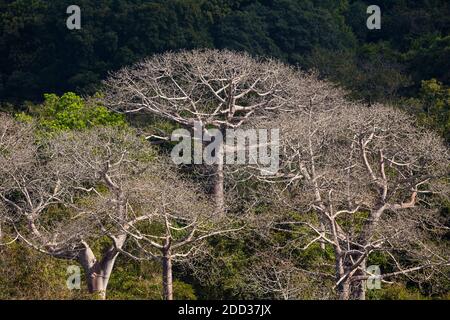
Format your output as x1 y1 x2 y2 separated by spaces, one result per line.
79 236 126 300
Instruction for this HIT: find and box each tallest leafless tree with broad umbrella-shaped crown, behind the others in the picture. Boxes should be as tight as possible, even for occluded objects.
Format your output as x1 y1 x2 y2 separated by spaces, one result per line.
104 50 296 212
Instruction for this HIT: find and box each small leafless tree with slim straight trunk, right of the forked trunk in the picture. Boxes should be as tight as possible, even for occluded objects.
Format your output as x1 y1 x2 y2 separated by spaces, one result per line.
110 168 242 300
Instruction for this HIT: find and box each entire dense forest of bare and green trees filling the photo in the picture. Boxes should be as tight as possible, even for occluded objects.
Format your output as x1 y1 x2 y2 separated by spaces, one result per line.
0 0 450 299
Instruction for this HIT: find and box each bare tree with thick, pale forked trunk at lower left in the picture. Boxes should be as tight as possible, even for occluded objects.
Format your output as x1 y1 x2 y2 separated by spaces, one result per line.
50 127 157 298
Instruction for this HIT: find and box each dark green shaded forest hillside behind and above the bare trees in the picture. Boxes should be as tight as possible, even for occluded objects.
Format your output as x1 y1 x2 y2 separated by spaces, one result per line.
0 0 450 139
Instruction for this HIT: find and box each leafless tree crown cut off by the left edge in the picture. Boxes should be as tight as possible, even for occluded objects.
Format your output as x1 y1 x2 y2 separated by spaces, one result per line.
0 115 92 290
